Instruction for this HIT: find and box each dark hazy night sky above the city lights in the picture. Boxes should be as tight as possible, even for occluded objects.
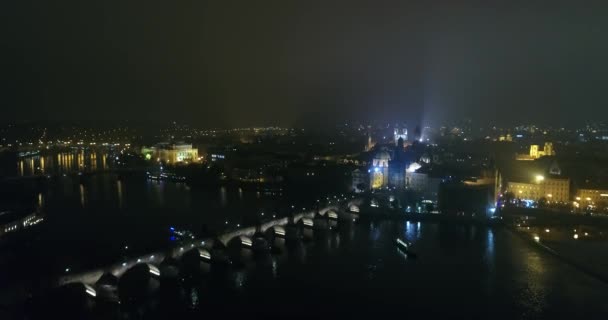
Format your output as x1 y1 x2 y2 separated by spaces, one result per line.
0 0 608 126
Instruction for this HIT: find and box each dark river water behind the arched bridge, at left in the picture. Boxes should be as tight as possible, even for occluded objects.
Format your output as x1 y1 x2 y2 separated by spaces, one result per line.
3 174 296 273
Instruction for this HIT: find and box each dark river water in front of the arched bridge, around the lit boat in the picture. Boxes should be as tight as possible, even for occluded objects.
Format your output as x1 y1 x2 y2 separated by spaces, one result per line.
100 221 608 319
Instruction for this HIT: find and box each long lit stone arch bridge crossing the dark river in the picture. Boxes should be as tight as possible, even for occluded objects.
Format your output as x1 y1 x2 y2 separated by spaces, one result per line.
57 198 363 286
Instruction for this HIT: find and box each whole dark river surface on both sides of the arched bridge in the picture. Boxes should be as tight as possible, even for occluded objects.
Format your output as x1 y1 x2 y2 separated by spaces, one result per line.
0 175 608 319
